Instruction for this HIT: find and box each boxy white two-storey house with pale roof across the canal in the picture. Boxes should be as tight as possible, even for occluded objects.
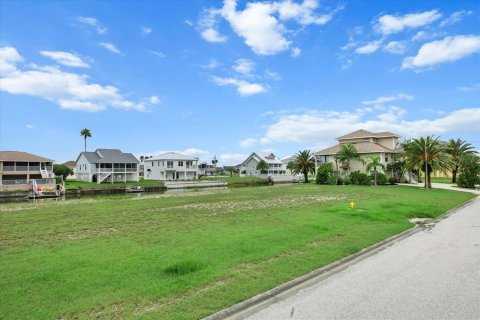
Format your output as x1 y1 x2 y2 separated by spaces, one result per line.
144 152 198 180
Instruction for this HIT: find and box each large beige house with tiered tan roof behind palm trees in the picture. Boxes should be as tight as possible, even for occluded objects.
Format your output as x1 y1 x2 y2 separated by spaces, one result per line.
315 130 400 172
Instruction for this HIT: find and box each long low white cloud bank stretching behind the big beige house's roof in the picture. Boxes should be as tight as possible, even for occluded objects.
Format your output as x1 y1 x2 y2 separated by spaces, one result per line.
261 107 480 144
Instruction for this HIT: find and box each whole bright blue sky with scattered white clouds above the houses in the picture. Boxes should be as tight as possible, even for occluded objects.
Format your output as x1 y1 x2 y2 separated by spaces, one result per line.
0 0 480 164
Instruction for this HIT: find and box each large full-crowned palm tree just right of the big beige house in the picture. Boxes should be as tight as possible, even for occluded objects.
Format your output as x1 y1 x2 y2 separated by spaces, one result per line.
404 136 452 189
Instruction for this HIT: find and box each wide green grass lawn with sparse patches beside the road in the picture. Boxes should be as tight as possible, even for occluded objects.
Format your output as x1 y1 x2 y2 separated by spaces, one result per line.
0 184 473 319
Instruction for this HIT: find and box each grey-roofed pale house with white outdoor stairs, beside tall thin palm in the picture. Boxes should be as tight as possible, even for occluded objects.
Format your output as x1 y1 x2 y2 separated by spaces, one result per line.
75 149 140 183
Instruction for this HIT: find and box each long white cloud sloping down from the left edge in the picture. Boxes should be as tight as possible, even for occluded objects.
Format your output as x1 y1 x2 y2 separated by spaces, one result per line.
0 47 156 112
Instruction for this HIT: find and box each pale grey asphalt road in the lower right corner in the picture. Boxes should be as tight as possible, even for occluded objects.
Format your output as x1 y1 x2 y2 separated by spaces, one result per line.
248 199 480 320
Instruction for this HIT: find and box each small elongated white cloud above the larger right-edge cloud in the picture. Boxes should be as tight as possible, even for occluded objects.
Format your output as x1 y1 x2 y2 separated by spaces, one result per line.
375 10 442 35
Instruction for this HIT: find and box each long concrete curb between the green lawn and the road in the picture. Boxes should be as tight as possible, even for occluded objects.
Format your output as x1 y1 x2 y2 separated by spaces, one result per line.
203 196 480 320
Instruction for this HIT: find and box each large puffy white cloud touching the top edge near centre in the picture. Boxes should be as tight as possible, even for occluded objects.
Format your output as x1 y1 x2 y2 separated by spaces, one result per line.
198 0 342 55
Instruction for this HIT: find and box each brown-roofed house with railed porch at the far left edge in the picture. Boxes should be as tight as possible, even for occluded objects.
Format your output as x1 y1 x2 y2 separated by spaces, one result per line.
0 151 55 190
